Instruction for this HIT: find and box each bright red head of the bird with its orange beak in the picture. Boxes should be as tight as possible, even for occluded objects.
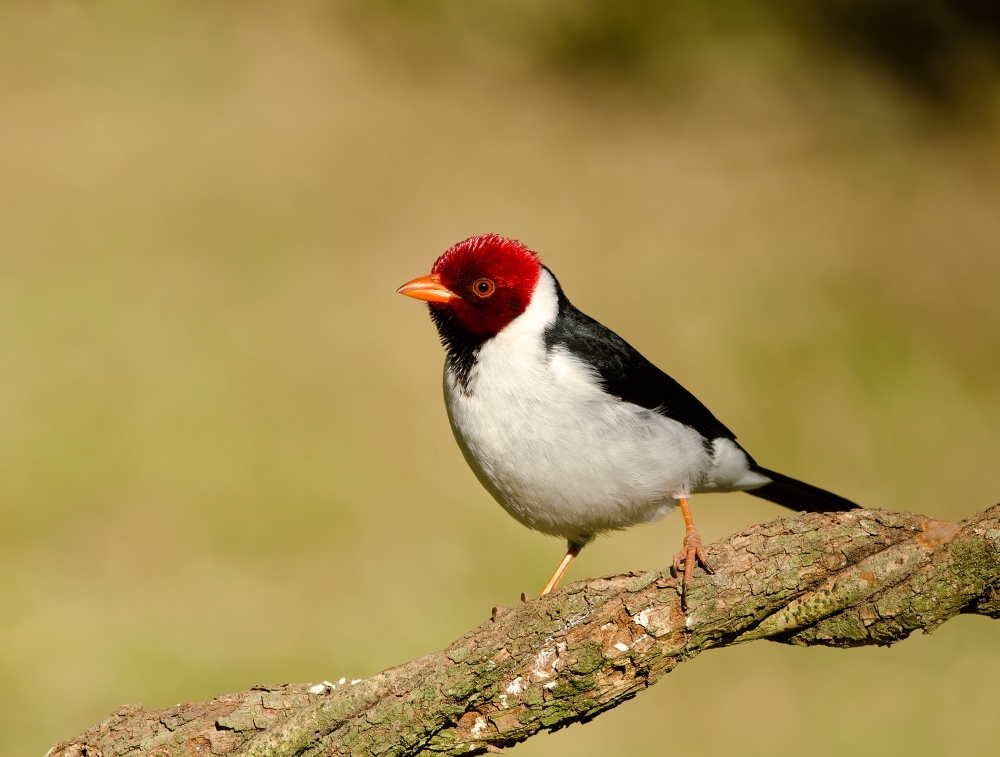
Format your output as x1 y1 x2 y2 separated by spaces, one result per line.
396 234 542 339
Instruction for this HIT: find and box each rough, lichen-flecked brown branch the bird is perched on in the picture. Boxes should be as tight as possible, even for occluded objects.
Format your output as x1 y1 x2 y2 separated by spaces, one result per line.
49 505 1000 757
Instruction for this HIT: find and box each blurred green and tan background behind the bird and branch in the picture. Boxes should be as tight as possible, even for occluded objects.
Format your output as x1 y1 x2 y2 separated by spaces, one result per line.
0 0 1000 756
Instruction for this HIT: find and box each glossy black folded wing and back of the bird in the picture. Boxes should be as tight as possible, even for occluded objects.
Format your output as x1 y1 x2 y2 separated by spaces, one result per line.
545 269 736 440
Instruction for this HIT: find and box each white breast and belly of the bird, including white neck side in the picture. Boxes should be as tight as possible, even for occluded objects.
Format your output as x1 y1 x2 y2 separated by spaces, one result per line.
444 271 714 542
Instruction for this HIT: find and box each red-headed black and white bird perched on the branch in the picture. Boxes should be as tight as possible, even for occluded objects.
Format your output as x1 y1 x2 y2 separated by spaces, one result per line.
396 234 858 607
